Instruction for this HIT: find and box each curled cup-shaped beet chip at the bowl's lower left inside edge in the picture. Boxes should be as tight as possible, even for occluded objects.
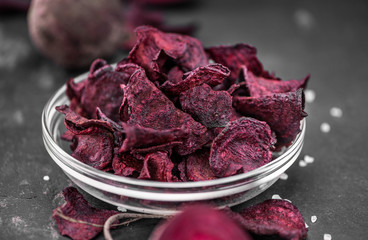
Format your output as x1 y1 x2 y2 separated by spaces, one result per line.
71 127 114 171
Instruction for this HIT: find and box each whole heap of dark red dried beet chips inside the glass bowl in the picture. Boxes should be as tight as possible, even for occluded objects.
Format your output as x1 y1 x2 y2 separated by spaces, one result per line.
57 26 309 182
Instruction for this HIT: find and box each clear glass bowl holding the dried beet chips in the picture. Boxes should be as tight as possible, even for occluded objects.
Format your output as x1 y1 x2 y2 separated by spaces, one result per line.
42 70 306 214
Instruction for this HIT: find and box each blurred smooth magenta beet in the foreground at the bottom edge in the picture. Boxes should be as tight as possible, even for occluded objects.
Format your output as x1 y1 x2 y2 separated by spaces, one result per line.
150 205 252 240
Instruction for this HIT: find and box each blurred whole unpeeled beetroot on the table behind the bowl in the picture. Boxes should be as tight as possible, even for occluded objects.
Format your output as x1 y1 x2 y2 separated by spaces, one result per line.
28 0 126 68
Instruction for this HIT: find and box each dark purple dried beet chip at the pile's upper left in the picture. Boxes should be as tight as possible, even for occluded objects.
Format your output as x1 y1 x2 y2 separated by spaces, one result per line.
67 59 130 120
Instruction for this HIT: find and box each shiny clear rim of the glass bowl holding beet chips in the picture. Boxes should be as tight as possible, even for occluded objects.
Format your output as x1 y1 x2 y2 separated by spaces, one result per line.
41 66 306 189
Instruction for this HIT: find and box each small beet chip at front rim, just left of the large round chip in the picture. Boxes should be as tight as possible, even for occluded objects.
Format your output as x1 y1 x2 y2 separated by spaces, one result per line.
185 148 217 181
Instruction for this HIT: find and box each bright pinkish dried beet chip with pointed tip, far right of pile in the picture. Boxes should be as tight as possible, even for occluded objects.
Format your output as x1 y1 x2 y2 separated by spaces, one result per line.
242 67 309 97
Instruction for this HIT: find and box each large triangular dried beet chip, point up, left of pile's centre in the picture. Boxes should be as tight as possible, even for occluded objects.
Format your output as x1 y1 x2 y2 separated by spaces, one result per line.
120 70 207 155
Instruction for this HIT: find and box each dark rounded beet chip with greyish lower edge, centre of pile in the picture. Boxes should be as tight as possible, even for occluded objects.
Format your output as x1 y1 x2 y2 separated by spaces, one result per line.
179 84 232 128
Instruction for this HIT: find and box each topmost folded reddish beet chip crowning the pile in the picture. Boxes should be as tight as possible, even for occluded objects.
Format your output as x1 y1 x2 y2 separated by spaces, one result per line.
128 26 208 81
